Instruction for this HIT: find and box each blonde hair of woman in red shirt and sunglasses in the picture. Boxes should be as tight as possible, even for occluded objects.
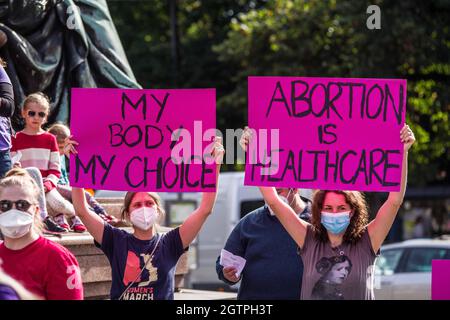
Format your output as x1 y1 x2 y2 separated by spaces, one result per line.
0 168 43 234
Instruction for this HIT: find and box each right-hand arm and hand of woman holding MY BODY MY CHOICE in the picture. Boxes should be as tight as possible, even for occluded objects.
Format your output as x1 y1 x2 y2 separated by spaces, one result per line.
180 138 225 248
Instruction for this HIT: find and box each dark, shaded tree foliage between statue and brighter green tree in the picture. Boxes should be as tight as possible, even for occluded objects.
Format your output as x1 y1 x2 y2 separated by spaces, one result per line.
108 0 266 91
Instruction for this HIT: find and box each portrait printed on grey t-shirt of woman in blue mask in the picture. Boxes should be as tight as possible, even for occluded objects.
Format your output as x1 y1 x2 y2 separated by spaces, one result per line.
311 255 352 300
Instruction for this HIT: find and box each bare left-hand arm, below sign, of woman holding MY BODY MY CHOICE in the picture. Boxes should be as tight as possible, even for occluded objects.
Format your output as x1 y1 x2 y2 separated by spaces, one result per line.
72 187 105 244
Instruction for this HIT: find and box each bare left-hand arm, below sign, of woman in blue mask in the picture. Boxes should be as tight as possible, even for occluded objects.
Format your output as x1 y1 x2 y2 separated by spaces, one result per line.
259 187 308 248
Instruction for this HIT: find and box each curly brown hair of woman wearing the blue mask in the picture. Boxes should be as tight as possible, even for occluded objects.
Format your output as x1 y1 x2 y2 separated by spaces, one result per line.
311 190 369 243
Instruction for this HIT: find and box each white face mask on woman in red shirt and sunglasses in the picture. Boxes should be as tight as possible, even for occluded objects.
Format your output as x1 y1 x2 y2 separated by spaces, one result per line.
0 209 34 239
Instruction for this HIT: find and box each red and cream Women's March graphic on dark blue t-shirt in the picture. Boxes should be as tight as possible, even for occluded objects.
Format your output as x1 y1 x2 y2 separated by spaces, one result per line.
122 251 158 300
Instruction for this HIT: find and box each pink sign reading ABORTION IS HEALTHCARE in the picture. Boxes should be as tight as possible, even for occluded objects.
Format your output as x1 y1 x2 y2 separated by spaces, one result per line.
245 77 407 191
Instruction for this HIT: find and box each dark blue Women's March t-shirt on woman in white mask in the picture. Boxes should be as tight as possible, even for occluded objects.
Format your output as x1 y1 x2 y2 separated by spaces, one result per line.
97 224 185 300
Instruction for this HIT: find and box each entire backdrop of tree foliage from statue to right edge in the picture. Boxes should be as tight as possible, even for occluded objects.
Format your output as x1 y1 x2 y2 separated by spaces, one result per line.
109 0 450 185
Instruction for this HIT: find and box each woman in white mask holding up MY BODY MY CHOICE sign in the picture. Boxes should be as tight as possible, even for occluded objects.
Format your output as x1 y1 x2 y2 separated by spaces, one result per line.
66 138 225 300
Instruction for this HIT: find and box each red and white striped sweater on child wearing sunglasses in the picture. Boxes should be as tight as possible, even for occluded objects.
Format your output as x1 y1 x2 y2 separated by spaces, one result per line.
11 132 61 191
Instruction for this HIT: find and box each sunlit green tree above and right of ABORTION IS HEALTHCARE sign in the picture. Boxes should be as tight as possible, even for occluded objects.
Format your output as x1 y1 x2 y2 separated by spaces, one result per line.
215 0 450 185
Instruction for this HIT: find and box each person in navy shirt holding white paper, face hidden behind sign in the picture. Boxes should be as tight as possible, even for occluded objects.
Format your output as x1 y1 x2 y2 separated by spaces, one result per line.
216 188 311 300
